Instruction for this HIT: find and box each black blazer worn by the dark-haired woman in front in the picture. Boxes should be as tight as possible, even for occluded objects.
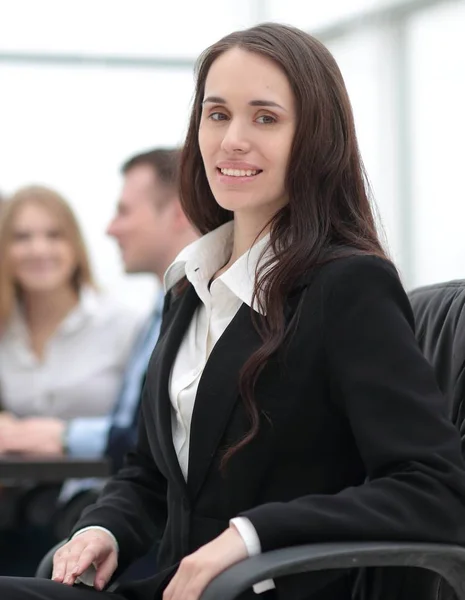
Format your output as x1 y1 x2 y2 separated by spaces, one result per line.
75 256 465 600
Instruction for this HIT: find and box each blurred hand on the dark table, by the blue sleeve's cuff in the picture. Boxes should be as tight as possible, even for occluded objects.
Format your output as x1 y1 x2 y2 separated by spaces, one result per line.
0 417 66 456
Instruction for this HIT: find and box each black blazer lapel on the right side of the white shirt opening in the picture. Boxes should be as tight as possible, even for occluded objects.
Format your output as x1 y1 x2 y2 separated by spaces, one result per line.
188 304 261 499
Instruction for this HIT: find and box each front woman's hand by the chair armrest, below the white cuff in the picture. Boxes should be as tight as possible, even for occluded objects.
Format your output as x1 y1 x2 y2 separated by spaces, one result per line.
163 526 248 600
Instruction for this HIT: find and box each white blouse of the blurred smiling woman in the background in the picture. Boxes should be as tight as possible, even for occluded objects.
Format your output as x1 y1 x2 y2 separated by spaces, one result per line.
0 288 141 420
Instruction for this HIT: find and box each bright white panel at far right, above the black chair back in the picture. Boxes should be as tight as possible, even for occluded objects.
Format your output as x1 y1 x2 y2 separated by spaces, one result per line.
410 1 465 285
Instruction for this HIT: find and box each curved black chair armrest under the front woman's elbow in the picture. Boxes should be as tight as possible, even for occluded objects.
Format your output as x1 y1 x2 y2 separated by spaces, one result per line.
200 542 465 600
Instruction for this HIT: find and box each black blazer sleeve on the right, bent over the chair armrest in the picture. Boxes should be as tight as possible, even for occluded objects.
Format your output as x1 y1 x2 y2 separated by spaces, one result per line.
241 256 465 551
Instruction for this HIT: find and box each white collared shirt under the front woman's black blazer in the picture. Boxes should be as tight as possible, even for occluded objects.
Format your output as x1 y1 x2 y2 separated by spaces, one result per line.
165 222 275 594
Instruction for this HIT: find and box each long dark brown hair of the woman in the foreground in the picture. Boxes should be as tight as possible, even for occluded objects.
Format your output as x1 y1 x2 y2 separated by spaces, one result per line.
180 23 386 466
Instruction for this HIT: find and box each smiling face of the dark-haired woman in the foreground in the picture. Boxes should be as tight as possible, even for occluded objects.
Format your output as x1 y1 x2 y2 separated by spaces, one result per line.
199 48 296 221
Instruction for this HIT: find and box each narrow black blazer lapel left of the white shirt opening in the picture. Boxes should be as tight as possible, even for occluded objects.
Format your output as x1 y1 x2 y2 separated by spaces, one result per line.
152 285 199 500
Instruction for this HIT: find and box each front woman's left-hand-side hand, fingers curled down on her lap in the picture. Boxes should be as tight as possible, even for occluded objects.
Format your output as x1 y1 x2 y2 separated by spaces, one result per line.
52 529 118 590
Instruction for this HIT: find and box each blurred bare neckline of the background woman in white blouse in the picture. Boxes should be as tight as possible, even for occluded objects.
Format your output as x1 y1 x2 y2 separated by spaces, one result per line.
23 286 79 330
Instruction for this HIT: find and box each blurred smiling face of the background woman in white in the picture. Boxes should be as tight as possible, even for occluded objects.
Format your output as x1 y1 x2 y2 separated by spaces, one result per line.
9 204 76 293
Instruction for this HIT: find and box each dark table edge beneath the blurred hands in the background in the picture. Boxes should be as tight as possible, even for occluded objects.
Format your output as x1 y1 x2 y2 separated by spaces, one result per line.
0 455 110 484
